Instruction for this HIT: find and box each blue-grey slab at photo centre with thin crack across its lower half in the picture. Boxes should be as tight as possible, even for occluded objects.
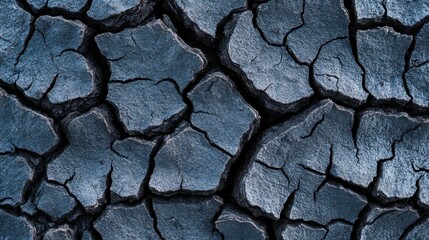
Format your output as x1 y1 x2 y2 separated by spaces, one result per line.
188 72 259 155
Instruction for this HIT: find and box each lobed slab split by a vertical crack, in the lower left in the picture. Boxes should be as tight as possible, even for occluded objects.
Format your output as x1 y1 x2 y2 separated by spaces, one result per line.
47 108 152 212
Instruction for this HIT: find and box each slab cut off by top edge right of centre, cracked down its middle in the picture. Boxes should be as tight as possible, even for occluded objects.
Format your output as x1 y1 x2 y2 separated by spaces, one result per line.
256 0 349 63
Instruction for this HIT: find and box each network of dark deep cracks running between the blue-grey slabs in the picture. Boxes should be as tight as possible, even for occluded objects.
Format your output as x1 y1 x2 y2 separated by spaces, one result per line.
0 0 429 239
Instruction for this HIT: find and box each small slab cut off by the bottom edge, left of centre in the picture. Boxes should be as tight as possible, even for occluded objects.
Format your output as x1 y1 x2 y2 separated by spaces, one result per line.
94 203 159 240
